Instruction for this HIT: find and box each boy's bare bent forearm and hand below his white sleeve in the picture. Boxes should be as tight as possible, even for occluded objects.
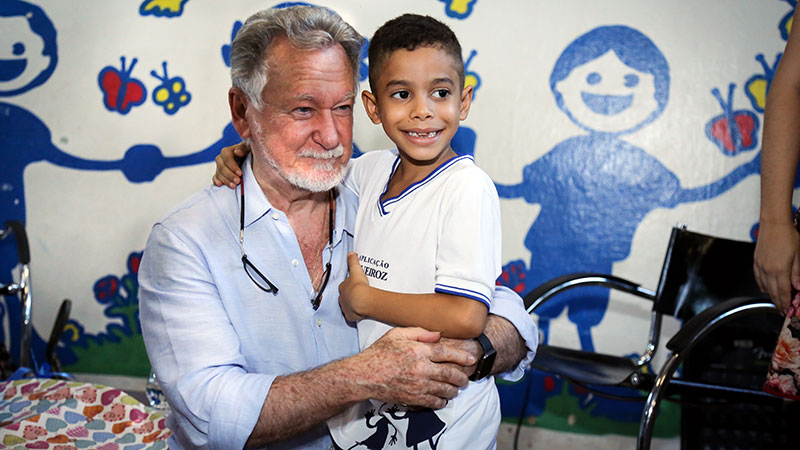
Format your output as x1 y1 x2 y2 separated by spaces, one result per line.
339 253 488 339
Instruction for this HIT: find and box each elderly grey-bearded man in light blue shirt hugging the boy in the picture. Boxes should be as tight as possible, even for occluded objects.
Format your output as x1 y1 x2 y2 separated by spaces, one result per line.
139 7 536 449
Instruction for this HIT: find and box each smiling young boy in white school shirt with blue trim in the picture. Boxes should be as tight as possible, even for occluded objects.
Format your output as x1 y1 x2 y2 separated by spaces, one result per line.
212 14 500 449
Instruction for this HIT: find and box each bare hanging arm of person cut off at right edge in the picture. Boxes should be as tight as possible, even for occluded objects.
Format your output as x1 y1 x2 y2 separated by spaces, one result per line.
754 4 800 311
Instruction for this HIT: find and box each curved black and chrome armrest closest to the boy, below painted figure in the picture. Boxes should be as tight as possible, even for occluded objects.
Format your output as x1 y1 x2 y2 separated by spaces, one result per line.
523 273 655 314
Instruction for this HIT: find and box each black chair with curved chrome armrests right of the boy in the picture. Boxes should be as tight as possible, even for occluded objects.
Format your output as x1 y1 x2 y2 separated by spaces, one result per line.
525 227 781 449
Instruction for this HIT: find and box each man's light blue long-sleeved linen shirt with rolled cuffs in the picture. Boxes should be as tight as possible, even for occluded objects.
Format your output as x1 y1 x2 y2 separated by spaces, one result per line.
139 158 538 450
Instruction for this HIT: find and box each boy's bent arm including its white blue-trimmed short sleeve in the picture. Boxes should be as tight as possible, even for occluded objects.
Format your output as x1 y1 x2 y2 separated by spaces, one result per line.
339 167 500 338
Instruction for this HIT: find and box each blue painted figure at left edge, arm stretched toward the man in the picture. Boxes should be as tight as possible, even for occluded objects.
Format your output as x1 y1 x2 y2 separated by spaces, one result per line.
0 0 239 368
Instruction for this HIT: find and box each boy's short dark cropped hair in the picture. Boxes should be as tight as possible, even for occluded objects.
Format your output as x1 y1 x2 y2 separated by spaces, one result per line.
369 14 464 92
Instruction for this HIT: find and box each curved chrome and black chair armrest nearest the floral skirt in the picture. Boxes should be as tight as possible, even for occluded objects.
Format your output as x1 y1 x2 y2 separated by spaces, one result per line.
667 297 780 352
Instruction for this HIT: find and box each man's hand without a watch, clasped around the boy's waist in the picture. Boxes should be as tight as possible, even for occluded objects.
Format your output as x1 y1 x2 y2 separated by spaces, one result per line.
351 328 475 409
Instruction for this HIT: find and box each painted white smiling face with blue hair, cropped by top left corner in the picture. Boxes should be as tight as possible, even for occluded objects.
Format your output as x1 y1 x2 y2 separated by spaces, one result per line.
0 1 57 96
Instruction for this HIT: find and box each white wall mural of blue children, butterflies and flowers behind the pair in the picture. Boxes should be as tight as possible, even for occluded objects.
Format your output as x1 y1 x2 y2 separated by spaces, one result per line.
0 0 800 448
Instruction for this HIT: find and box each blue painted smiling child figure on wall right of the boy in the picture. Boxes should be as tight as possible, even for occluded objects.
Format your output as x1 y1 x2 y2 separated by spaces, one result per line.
497 26 759 350
